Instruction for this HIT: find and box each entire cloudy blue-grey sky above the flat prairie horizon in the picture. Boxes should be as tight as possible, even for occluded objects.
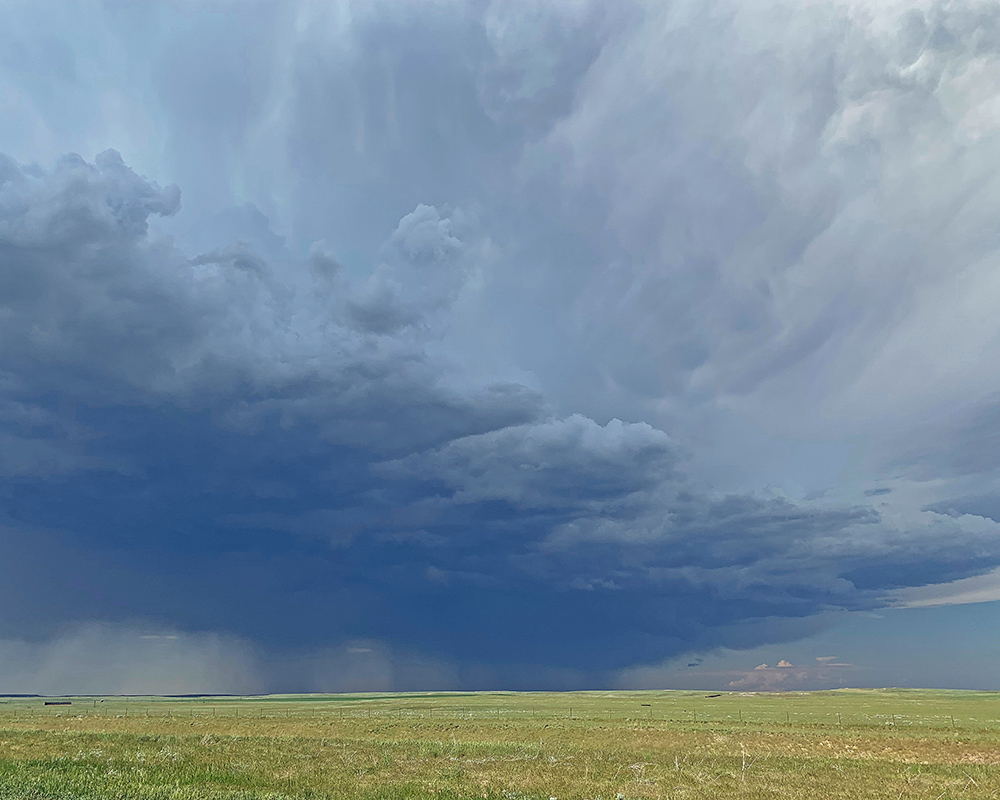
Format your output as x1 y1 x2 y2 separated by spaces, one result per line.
0 0 1000 693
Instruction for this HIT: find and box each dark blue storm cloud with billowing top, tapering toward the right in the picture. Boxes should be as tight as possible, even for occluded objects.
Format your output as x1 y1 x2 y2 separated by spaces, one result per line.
0 153 1000 680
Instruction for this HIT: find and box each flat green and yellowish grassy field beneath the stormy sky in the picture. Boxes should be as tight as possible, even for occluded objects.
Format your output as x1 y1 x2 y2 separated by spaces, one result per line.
0 690 1000 800
